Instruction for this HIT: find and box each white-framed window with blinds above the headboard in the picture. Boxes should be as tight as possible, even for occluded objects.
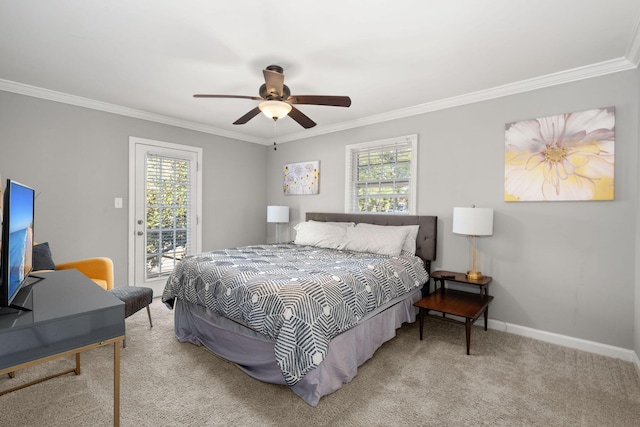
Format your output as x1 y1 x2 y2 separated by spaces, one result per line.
345 135 418 214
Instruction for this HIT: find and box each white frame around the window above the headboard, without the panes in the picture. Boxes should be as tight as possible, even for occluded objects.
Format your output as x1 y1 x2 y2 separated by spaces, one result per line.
344 134 418 215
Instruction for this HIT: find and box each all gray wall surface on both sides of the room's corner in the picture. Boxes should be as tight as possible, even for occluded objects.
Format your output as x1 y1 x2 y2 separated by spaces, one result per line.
0 70 640 353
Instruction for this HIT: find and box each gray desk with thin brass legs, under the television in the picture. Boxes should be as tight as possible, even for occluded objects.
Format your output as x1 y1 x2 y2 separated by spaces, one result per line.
0 270 124 426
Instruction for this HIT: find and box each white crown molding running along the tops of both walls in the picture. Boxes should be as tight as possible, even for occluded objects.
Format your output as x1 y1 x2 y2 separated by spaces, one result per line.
0 54 640 146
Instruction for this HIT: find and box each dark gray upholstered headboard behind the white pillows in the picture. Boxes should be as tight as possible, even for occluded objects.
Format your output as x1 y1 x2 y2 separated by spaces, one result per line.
306 212 438 266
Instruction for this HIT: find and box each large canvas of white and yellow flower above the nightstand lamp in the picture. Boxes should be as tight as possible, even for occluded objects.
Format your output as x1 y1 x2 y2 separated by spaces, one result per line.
504 107 615 201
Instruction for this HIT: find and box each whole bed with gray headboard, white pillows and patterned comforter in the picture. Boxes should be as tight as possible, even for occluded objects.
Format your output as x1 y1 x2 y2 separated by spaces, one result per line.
162 213 437 406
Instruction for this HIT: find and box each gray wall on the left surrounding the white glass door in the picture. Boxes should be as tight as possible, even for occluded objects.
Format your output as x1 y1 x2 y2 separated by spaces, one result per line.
0 91 267 286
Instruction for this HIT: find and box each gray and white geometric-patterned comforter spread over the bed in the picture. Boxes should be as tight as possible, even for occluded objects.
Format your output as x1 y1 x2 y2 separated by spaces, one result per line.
162 244 428 385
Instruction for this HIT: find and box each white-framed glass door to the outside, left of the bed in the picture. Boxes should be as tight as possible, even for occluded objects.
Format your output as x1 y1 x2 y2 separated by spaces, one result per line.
130 138 202 296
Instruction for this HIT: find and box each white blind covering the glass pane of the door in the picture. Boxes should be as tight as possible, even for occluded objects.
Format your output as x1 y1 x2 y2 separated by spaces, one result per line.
145 154 192 278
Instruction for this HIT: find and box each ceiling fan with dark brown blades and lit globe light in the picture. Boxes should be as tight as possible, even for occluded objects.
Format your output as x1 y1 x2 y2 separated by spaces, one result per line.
193 65 351 129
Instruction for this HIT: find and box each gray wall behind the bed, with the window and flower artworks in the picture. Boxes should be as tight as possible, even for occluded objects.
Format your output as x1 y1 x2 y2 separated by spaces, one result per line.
268 70 639 349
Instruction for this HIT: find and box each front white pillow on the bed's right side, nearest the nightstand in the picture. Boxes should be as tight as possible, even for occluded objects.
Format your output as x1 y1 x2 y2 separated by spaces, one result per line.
339 224 409 256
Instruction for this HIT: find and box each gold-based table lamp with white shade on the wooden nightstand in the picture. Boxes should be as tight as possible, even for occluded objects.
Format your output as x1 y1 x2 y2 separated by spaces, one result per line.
453 206 493 280
